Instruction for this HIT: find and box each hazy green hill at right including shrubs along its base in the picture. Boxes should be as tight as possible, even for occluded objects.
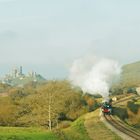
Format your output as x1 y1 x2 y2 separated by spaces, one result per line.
110 61 140 95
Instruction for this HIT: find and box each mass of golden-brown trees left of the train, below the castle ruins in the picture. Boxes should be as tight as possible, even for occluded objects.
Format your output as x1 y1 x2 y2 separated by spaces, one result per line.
0 80 98 129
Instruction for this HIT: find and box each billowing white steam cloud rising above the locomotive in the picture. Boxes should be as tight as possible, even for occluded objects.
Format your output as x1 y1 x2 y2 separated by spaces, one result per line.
69 56 121 97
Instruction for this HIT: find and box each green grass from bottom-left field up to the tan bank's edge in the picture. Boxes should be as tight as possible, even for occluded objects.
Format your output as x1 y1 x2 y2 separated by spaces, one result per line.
0 118 90 140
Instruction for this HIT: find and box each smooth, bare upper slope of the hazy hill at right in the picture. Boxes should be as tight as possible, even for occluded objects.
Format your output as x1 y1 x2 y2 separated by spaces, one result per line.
121 61 140 87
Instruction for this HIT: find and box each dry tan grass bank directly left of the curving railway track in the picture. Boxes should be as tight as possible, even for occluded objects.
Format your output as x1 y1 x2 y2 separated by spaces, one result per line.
85 109 122 140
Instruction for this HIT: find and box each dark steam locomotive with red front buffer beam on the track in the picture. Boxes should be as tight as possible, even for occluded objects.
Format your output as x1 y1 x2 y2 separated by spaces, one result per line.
101 99 112 115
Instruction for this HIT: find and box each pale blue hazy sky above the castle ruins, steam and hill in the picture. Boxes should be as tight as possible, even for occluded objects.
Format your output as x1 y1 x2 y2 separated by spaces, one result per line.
0 0 140 79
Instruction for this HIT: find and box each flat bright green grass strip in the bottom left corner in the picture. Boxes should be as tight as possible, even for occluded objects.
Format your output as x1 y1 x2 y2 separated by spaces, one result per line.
0 127 58 140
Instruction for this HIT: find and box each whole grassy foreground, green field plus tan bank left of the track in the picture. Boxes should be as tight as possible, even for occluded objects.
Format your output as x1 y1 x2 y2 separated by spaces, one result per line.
0 110 121 140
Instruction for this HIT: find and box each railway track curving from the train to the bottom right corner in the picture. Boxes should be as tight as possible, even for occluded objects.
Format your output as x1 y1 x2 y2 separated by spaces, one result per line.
104 115 140 140
